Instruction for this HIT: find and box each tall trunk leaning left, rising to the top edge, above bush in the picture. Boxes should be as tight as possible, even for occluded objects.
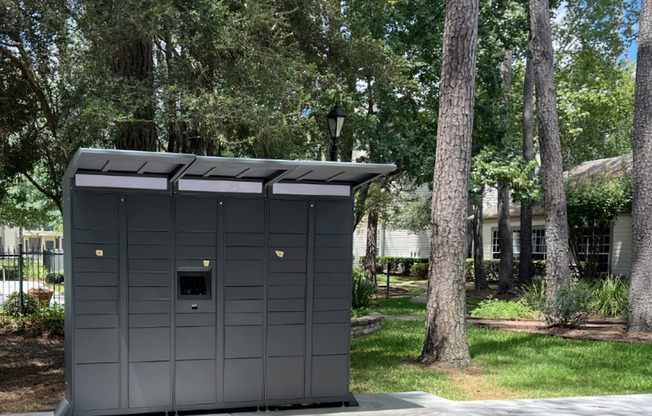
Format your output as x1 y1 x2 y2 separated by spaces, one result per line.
530 0 571 301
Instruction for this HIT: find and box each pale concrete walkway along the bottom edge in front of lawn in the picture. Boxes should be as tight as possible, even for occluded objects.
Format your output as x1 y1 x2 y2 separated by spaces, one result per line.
6 391 652 416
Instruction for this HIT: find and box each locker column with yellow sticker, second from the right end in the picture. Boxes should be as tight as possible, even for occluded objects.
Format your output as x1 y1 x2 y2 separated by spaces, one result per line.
266 199 309 400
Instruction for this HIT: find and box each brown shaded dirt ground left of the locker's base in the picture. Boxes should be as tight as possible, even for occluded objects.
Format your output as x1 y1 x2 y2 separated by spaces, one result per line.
0 328 65 414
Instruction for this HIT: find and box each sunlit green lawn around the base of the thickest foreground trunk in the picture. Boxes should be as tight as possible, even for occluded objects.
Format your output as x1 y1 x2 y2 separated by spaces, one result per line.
351 321 652 400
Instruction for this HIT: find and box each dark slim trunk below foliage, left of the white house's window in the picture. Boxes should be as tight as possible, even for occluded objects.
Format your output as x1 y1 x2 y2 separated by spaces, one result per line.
498 181 514 294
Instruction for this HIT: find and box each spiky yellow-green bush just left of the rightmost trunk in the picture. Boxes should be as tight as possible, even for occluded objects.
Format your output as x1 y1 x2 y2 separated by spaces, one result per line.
591 275 629 317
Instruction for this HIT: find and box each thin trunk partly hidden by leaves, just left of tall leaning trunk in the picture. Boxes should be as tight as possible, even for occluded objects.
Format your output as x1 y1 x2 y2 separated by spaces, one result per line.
518 58 534 286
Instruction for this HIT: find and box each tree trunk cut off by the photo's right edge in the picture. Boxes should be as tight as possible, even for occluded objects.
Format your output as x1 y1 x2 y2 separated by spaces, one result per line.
628 0 652 333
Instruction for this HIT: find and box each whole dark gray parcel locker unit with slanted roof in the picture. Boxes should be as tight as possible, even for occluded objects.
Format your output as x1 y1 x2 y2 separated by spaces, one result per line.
55 149 394 416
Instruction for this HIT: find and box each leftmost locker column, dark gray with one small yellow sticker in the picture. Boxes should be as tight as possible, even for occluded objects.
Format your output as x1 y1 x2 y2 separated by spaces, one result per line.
68 192 120 413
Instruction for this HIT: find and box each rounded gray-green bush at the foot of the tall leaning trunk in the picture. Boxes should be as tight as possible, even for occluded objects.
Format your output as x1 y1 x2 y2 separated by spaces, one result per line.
542 283 591 328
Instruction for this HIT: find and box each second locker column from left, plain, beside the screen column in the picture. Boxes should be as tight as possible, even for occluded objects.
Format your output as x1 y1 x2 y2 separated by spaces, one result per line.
126 195 172 411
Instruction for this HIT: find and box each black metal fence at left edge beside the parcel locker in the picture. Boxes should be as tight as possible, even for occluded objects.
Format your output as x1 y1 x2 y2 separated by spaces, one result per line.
0 244 64 319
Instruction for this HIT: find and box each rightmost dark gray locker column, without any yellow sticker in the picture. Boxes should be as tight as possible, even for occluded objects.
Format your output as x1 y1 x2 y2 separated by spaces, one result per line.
311 200 353 398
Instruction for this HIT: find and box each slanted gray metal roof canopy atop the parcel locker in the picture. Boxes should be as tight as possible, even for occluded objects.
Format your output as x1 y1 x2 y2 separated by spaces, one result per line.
66 148 396 188
